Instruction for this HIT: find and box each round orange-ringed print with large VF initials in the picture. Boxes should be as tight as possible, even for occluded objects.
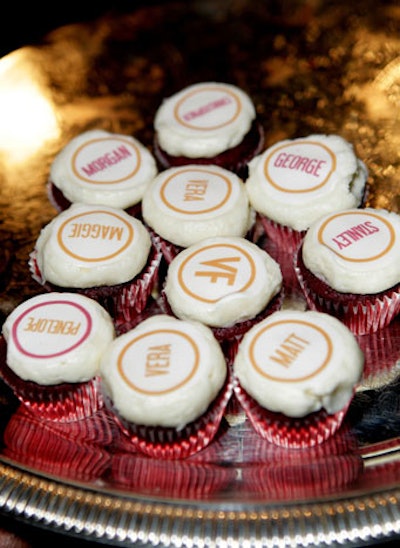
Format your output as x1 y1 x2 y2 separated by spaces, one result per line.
178 244 256 303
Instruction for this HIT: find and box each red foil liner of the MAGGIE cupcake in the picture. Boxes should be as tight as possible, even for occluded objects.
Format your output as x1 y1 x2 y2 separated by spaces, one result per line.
29 245 162 327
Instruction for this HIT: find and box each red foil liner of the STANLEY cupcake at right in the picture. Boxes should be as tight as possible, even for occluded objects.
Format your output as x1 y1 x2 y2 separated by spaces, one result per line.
294 248 400 335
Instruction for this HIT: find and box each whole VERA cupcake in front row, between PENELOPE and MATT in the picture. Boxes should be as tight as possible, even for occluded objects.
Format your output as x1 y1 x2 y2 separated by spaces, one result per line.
100 314 232 459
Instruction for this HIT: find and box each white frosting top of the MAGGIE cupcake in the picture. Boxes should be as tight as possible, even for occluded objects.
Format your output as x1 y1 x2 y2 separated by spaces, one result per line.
35 203 151 288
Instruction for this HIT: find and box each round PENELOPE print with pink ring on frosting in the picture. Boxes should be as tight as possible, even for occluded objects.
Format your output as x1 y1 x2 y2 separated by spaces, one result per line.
12 299 93 359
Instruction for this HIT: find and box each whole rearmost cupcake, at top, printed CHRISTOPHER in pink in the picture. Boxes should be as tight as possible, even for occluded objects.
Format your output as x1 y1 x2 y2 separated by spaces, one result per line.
154 82 264 178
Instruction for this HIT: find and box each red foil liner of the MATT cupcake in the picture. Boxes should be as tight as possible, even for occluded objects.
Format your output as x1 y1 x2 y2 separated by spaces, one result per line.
234 383 350 449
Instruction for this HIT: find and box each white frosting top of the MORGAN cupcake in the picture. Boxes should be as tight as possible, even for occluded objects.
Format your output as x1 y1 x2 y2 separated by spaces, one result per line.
49 130 158 209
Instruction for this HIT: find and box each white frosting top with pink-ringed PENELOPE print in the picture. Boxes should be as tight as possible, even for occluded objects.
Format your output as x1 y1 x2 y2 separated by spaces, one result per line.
2 292 115 385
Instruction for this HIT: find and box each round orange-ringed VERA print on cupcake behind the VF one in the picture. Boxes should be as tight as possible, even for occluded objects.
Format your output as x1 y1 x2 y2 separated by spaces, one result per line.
158 168 236 218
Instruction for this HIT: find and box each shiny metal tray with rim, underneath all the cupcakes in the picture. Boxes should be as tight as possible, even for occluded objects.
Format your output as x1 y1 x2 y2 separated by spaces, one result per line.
0 0 400 546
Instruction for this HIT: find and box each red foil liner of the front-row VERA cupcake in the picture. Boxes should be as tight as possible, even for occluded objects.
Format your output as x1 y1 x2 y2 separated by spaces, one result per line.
104 376 232 459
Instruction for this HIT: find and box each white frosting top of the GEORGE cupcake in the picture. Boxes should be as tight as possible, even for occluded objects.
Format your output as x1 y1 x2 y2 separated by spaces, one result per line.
246 135 368 231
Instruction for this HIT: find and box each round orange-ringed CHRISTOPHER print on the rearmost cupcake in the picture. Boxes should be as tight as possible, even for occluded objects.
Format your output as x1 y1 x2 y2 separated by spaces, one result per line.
174 86 242 130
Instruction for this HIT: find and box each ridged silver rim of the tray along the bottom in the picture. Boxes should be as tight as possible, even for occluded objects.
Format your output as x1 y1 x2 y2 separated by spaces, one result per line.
0 457 400 547
